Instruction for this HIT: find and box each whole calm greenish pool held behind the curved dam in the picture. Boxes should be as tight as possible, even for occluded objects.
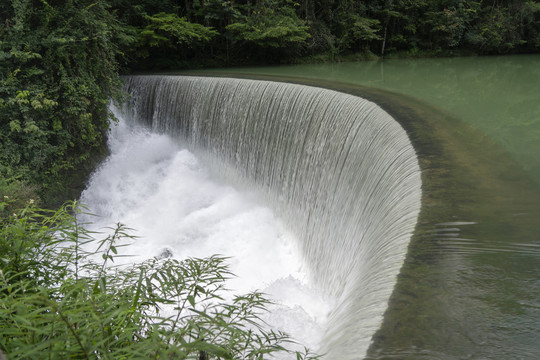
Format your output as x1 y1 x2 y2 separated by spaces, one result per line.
194 55 540 359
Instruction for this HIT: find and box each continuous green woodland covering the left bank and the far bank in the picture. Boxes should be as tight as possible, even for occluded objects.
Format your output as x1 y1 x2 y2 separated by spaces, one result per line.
0 0 540 205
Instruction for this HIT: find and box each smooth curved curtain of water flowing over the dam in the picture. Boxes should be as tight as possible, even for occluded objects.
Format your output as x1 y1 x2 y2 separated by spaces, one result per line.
118 76 422 359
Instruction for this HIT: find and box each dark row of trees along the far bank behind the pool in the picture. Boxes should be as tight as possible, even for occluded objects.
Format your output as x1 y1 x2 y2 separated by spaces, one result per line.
112 0 540 68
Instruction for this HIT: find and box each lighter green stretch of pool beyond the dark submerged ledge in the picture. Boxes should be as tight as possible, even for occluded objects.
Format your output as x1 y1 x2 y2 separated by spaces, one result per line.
202 55 540 190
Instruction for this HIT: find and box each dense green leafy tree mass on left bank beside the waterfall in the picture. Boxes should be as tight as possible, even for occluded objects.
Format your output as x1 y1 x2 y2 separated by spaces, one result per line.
0 0 132 203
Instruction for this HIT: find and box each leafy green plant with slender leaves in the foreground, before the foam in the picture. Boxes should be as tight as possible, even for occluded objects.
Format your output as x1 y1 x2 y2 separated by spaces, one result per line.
0 201 313 359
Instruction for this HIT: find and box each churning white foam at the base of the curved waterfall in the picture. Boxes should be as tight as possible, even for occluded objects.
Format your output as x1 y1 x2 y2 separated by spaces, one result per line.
81 114 330 356
